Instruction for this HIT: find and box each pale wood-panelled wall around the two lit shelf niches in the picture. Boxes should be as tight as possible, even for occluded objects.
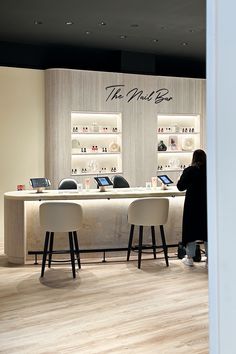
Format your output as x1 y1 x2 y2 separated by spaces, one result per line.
45 69 205 188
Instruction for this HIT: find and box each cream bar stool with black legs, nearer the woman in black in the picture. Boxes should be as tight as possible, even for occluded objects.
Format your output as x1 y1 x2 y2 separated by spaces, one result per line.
127 198 169 269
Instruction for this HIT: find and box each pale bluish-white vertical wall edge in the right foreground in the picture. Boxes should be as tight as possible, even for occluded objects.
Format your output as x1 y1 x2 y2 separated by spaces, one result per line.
207 0 236 354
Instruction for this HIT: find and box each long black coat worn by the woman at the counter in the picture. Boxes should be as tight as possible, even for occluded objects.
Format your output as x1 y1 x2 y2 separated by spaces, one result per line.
177 166 207 246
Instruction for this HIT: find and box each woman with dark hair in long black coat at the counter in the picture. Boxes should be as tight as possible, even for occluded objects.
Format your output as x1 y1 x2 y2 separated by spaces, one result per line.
177 149 207 266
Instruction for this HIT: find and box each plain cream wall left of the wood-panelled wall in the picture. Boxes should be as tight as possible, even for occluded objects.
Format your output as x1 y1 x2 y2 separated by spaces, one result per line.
0 67 45 244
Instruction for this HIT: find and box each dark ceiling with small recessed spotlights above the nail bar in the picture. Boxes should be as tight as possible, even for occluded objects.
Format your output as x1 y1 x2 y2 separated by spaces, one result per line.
0 0 206 77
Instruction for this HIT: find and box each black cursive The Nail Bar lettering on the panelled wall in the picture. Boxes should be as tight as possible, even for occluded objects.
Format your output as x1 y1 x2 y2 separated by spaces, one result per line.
105 85 173 104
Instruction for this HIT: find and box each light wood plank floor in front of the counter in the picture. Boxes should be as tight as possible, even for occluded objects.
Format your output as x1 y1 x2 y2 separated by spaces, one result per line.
0 256 208 354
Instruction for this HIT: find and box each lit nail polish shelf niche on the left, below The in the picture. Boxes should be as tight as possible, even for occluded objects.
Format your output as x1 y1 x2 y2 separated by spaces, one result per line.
71 112 122 175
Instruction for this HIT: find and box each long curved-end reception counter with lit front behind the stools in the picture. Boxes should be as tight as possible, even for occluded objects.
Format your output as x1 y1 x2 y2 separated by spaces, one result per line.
4 187 184 264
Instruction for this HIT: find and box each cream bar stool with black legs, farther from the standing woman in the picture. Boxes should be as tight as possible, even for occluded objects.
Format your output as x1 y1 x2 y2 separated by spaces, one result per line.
39 202 83 278
